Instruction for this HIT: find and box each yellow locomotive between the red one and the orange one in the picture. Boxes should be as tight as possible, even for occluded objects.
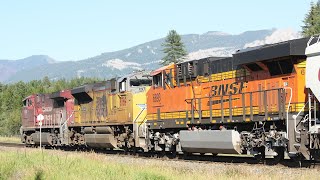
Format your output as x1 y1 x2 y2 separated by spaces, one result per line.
70 72 151 148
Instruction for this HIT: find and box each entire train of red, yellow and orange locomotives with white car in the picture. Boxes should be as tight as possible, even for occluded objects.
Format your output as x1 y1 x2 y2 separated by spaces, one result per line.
20 36 320 160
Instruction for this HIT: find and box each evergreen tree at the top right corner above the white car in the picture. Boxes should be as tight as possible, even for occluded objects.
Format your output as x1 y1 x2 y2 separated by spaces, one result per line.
302 1 320 37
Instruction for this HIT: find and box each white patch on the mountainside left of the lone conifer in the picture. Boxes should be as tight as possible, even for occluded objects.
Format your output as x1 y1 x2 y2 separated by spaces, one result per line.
102 59 142 70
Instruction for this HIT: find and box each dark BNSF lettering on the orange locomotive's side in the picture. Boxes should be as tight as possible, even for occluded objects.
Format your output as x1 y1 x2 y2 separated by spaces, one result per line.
212 82 246 96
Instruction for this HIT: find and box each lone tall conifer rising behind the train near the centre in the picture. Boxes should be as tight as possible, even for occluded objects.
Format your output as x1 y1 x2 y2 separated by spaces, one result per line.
161 30 187 65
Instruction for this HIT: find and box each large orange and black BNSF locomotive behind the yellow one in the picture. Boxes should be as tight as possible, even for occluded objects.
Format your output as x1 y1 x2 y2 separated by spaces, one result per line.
147 38 320 159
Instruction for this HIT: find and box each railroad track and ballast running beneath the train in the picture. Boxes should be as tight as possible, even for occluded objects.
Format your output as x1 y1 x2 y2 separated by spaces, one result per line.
0 142 320 169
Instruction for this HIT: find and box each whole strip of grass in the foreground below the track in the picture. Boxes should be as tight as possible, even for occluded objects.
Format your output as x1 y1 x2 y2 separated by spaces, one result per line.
0 148 319 180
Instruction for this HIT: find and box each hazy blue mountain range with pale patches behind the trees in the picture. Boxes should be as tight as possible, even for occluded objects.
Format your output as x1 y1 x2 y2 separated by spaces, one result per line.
0 29 296 83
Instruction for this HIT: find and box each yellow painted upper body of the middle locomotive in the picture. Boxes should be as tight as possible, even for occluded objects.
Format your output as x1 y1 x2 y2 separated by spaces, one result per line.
74 82 149 125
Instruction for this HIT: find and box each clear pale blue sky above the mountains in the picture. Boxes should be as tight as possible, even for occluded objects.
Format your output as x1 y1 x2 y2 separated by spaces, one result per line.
0 0 312 61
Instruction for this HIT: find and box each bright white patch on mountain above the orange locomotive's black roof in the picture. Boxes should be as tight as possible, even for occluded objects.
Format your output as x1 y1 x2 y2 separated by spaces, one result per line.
243 29 301 48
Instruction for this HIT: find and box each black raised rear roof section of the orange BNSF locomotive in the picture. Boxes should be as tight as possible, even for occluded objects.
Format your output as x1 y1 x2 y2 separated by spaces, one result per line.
233 38 309 65
